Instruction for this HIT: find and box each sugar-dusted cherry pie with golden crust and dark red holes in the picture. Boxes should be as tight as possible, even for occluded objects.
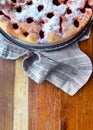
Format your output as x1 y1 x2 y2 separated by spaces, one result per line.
0 0 93 44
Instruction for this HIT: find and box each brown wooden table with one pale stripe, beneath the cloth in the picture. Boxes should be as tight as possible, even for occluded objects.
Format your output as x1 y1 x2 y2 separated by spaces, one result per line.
0 29 93 130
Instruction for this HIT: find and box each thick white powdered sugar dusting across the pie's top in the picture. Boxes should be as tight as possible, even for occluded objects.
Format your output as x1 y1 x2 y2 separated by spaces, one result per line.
2 0 89 42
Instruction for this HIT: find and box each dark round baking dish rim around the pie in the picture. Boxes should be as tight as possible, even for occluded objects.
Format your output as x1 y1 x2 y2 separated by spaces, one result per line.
0 18 93 51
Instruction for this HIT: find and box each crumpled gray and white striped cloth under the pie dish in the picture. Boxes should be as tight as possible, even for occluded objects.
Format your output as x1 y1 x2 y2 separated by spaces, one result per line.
0 33 92 96
